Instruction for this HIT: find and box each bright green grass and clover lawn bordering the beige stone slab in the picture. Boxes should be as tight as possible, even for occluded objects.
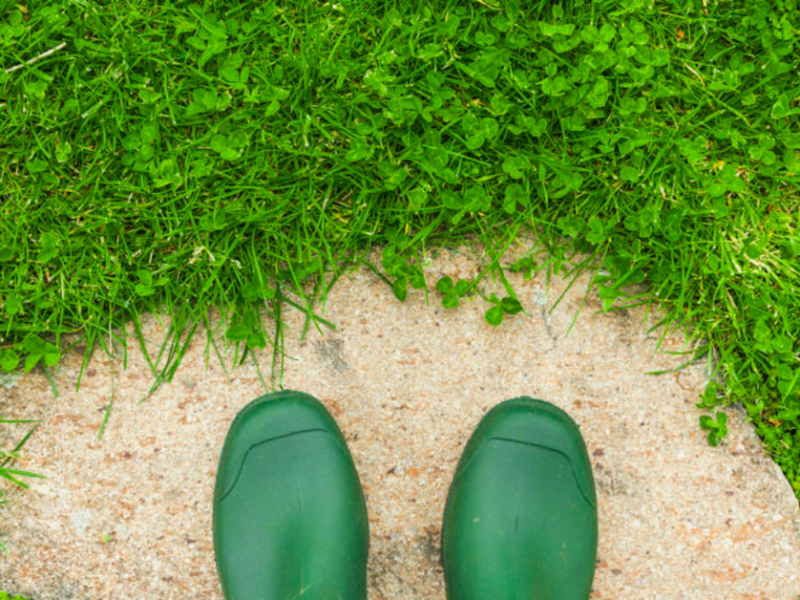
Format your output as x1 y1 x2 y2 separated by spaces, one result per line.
0 0 800 544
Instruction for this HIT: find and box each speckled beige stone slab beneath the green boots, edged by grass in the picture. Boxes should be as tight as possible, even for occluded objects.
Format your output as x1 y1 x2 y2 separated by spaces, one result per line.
0 240 800 600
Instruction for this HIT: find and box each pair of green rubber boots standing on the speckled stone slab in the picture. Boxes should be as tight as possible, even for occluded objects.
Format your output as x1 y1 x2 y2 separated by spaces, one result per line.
214 391 597 600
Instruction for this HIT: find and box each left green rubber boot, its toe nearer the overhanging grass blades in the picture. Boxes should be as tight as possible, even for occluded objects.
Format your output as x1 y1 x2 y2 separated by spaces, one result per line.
214 391 369 600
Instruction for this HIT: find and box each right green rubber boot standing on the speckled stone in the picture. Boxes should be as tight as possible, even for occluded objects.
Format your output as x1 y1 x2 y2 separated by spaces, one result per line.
442 398 597 600
